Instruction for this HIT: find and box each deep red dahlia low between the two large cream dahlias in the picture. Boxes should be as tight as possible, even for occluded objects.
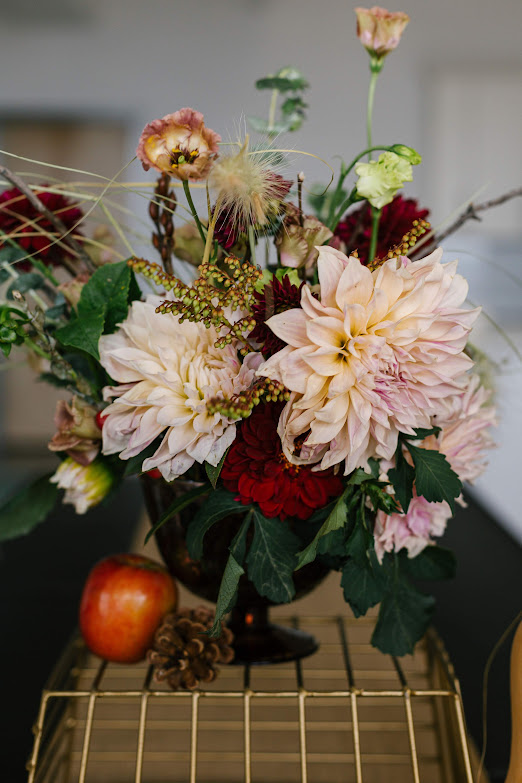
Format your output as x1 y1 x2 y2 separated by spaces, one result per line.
221 403 343 519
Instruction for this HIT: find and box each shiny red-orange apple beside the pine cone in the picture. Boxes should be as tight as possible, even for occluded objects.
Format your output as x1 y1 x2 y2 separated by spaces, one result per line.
80 555 178 663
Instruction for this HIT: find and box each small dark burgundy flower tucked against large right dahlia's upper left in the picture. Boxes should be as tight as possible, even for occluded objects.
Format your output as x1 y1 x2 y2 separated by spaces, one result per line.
249 275 303 359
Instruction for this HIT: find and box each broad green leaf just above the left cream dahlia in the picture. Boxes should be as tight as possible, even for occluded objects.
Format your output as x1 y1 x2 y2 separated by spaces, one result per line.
78 261 131 334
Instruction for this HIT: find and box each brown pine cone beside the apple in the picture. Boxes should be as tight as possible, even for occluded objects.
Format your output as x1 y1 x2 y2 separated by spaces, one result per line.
147 606 234 691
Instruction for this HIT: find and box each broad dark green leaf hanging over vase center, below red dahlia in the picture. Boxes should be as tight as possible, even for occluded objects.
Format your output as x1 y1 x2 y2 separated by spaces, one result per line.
246 509 299 604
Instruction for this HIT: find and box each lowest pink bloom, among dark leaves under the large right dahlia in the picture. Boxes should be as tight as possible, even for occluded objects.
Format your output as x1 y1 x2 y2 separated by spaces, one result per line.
373 495 451 563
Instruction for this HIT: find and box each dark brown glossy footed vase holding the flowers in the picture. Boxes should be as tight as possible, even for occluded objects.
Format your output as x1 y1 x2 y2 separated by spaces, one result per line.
142 475 329 664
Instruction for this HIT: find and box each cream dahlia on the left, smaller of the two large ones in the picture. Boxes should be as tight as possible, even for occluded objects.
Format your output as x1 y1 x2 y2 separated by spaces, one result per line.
99 296 261 481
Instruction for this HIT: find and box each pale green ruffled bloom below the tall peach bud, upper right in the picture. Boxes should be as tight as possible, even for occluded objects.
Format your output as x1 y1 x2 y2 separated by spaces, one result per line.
355 152 413 209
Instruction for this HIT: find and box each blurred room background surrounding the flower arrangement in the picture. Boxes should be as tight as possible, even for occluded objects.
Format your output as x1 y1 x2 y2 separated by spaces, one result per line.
0 0 522 781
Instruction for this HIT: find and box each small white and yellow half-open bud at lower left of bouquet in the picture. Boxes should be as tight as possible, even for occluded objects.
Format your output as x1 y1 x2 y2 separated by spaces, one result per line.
49 457 114 514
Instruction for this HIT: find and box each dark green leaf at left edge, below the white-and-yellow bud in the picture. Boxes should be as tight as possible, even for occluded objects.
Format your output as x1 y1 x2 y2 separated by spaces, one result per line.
0 473 59 541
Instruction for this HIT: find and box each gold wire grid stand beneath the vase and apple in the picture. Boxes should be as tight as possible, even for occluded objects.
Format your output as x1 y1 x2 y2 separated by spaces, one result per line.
28 617 473 783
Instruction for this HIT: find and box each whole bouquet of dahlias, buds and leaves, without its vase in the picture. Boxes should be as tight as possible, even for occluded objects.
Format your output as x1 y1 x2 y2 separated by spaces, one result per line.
0 8 504 655
